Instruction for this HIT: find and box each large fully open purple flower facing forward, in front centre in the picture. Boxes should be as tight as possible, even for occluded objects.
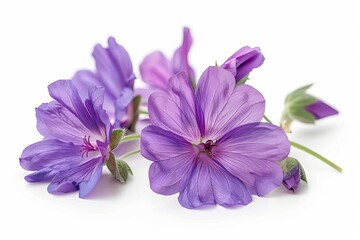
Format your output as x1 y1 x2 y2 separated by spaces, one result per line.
141 67 290 208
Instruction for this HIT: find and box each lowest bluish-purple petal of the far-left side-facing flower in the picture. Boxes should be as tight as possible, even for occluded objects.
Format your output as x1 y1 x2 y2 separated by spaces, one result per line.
48 157 103 197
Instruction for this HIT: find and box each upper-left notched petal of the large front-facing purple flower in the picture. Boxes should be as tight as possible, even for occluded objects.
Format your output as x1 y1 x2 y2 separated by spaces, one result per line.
148 72 200 143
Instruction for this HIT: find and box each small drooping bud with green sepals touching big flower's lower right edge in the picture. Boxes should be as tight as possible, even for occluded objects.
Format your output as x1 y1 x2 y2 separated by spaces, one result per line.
281 157 307 192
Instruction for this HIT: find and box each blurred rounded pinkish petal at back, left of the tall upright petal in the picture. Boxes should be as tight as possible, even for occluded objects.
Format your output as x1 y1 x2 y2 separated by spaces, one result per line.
140 51 174 90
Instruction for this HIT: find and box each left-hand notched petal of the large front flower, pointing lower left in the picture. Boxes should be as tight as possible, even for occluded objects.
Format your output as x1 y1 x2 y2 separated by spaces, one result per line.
140 126 197 195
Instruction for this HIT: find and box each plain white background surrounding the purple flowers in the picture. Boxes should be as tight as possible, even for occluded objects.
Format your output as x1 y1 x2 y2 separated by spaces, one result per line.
0 0 360 239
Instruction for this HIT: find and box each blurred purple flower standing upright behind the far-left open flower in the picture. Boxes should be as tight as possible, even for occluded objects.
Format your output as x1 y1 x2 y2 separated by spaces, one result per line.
73 37 135 128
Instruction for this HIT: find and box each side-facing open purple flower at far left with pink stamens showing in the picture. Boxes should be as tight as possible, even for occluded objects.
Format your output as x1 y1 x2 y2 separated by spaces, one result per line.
20 80 112 197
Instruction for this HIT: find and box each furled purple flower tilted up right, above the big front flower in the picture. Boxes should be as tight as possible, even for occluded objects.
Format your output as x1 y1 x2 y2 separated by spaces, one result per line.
220 46 265 82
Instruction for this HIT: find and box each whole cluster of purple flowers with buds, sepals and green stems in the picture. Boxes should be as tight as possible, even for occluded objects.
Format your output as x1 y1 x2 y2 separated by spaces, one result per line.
20 28 341 208
